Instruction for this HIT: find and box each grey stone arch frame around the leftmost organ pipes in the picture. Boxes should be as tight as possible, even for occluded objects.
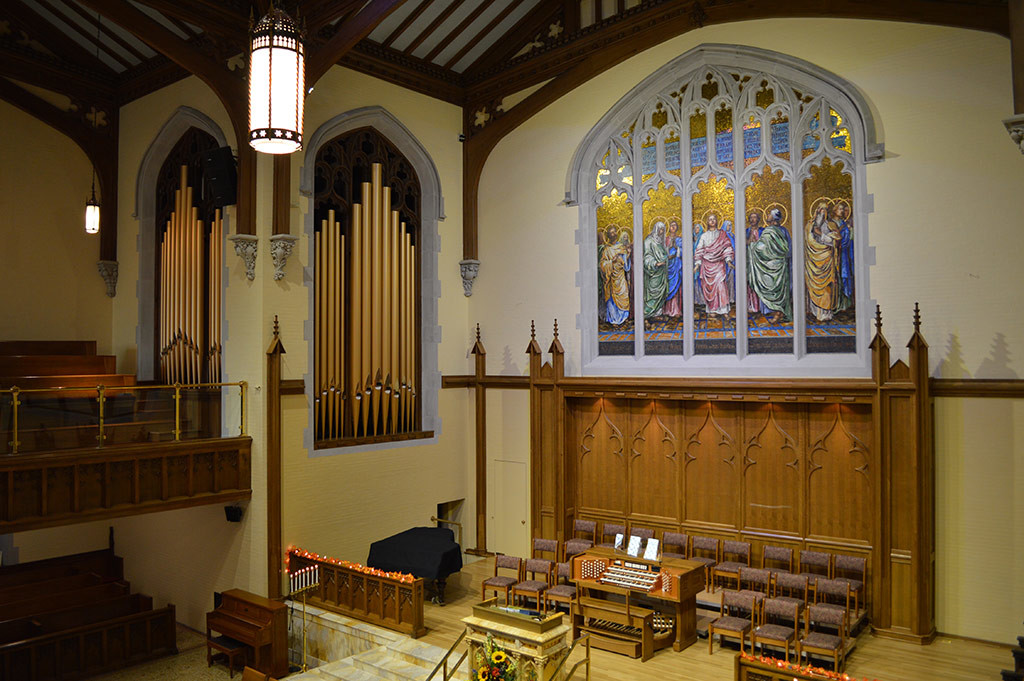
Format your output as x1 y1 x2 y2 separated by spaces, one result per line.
133 105 231 381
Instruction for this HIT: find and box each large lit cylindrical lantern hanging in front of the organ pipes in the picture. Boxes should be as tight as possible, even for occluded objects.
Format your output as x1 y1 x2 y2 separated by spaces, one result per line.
249 5 305 154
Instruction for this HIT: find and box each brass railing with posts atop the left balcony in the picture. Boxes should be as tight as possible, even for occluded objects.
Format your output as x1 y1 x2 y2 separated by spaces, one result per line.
0 381 249 454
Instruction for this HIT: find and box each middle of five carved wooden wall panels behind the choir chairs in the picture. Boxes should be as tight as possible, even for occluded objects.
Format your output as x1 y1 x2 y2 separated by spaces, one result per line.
682 401 742 531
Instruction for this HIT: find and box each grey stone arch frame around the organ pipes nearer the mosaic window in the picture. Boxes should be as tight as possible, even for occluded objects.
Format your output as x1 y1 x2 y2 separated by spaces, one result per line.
299 107 444 456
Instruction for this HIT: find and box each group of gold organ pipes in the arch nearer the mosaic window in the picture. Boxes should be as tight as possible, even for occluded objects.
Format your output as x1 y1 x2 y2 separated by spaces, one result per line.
313 164 417 440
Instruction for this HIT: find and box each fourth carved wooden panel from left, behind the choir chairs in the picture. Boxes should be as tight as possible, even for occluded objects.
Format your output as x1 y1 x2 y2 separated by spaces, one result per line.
741 402 806 536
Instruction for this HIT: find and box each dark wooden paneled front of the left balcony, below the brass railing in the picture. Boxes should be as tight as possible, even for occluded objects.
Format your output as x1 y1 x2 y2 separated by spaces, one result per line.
0 436 252 534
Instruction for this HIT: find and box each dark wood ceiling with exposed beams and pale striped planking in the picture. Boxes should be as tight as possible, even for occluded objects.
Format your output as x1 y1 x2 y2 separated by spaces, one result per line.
0 0 1008 115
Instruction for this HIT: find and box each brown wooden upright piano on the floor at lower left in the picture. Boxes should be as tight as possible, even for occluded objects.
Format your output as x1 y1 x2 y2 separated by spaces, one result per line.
206 589 288 678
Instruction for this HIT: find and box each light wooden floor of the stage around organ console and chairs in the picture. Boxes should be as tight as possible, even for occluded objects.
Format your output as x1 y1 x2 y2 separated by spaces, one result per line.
421 559 1013 681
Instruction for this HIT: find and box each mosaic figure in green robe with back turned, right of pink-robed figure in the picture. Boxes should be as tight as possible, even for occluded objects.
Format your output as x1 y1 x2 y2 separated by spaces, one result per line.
746 208 793 324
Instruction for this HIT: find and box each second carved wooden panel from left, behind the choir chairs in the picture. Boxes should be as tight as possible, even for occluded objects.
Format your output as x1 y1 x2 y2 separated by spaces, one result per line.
627 400 682 529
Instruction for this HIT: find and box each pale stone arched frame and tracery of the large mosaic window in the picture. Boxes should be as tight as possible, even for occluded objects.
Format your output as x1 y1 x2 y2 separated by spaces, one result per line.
564 44 885 377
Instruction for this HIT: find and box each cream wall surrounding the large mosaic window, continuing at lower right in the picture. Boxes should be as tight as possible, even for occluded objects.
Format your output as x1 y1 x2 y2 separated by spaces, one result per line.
469 19 1024 642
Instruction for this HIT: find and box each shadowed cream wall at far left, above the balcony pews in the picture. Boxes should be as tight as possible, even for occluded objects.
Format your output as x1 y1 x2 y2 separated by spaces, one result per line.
0 101 114 354
